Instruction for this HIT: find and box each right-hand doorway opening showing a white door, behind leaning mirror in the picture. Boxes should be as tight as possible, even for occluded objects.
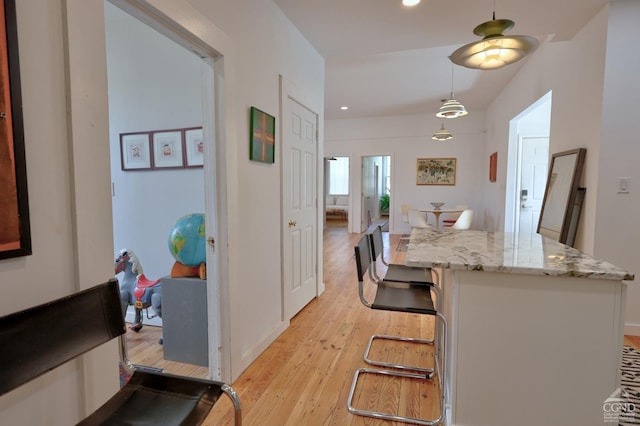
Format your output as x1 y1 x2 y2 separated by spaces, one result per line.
504 92 552 233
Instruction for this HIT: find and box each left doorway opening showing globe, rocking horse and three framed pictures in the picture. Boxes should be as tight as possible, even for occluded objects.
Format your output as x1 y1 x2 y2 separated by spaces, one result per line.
104 0 230 380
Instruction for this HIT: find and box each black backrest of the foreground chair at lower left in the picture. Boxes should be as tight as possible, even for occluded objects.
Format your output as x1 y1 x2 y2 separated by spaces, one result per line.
0 279 126 395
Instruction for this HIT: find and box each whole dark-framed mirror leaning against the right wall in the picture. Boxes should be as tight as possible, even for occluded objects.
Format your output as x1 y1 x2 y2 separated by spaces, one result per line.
538 148 587 246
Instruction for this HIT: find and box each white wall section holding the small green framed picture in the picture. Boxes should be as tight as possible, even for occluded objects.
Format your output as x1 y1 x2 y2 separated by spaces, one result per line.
185 0 324 377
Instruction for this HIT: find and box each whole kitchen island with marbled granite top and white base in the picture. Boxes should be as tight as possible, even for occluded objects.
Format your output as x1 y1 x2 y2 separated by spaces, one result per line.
405 229 634 426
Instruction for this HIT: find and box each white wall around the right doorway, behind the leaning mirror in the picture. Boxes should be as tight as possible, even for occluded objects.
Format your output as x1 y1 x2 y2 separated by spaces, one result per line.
484 7 615 253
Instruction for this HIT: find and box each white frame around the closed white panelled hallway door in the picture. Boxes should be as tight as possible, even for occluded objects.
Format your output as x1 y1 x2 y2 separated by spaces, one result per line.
278 75 325 323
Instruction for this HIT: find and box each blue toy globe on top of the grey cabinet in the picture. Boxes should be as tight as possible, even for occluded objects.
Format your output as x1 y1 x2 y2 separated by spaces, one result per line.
169 213 206 266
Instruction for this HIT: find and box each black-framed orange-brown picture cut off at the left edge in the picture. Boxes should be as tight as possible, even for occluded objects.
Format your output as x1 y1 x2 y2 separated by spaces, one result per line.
0 0 31 259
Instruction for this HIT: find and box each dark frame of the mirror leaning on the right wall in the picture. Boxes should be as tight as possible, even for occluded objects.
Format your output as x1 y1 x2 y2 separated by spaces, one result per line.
537 148 587 244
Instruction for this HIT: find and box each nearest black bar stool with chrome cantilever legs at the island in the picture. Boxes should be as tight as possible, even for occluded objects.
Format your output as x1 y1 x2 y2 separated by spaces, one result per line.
347 235 447 425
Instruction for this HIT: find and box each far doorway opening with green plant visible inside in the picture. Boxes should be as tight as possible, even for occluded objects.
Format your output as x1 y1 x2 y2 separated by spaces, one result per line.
360 155 392 232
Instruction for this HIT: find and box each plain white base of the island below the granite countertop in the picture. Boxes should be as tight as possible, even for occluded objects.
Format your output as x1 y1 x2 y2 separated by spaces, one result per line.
444 270 626 426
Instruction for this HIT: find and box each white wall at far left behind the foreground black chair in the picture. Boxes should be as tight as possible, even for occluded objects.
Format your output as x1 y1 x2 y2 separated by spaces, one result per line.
0 0 118 426
